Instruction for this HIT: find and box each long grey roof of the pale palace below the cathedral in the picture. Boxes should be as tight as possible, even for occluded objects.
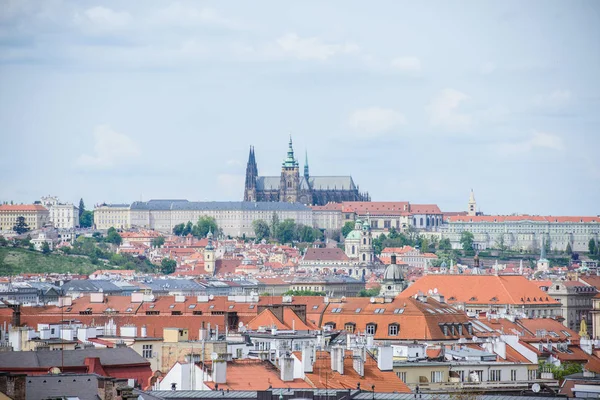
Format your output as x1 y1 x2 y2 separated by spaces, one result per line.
131 200 310 211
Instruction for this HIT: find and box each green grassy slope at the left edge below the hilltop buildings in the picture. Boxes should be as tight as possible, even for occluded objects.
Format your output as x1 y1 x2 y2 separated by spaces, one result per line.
0 247 99 276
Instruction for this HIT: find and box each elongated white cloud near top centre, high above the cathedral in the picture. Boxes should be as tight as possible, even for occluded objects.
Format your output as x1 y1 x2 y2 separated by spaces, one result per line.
277 33 360 61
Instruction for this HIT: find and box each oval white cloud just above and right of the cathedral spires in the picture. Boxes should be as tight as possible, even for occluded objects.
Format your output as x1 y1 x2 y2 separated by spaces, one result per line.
349 107 406 136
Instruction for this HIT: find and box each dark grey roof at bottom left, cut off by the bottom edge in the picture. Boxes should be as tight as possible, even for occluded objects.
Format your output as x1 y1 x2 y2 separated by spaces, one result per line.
25 374 100 400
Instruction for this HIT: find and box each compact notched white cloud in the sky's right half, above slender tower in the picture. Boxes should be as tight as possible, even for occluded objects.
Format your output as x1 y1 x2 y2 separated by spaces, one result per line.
427 88 473 130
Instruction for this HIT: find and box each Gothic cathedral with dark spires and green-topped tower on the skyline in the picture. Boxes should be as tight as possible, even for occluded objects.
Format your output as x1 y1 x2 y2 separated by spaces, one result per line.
244 137 371 205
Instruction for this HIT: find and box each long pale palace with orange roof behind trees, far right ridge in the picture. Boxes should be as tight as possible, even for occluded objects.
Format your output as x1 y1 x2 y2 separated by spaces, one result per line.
441 215 600 251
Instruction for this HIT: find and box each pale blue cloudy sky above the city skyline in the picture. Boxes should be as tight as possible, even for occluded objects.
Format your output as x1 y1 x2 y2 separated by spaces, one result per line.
0 0 600 215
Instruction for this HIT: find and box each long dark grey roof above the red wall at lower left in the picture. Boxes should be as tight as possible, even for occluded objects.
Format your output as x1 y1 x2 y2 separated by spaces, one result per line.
0 347 148 370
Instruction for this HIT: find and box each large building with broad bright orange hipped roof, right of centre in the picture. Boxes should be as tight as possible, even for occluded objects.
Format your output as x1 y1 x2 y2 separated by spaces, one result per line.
399 274 561 317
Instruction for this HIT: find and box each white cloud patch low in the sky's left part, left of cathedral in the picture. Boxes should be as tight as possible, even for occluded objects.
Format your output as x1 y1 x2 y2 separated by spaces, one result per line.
77 125 142 169
